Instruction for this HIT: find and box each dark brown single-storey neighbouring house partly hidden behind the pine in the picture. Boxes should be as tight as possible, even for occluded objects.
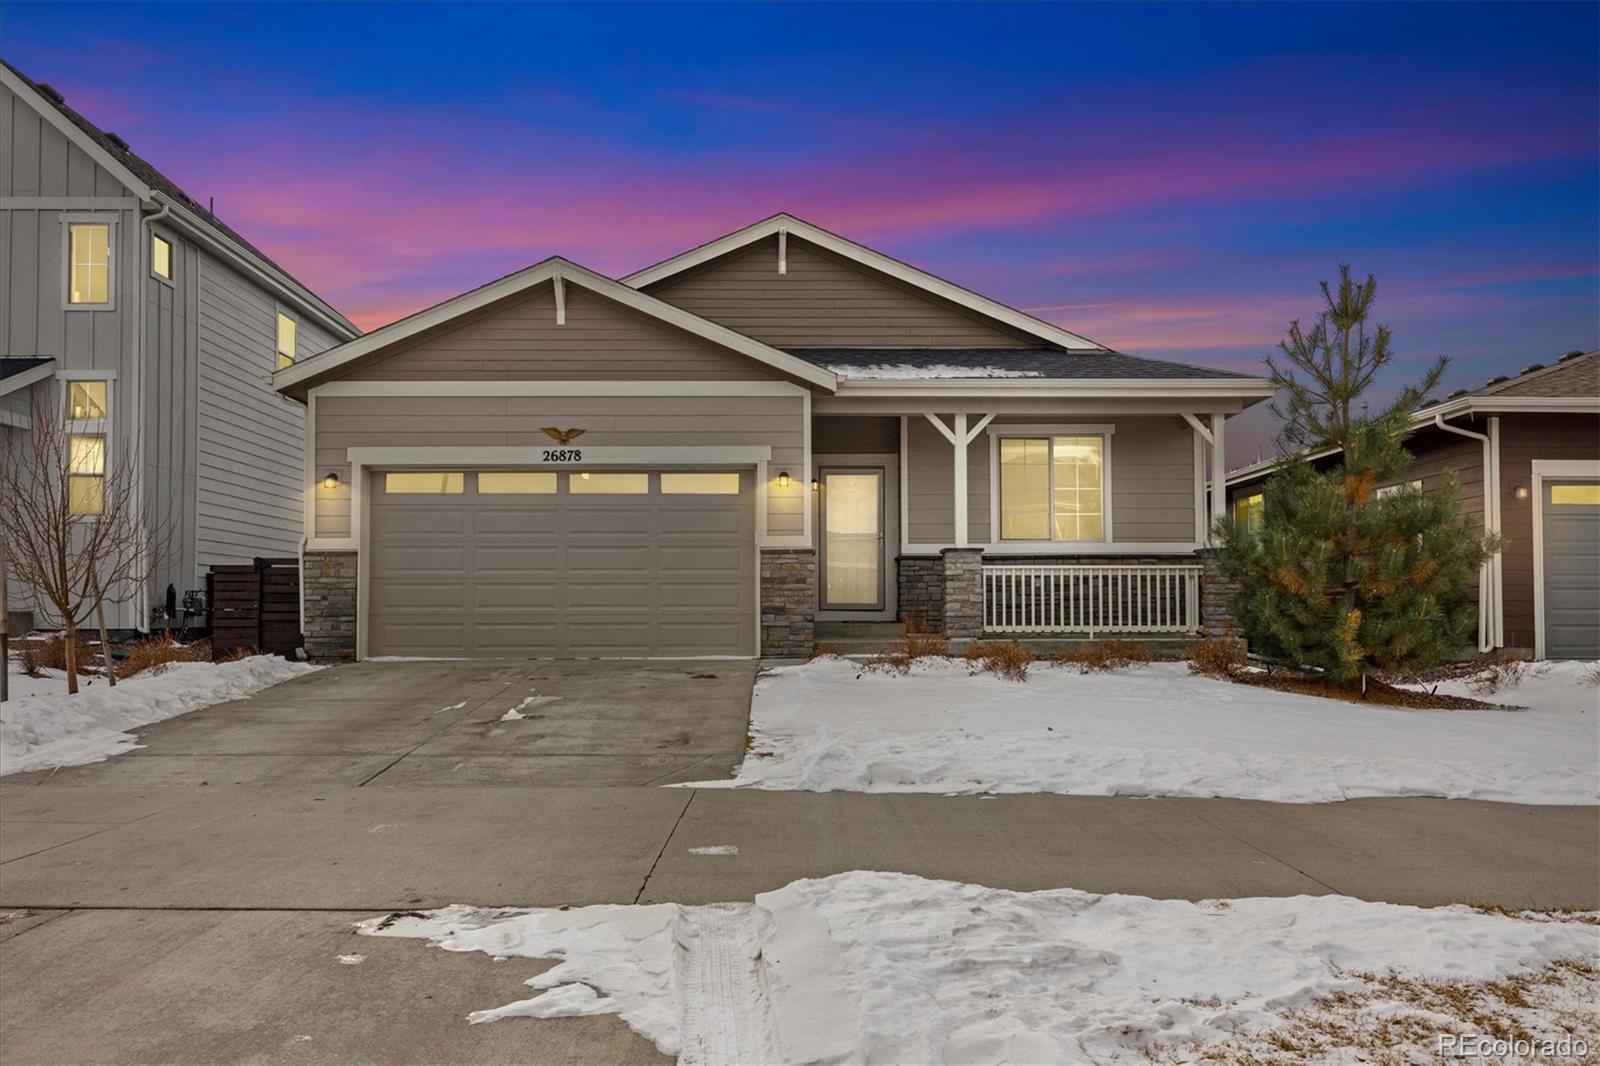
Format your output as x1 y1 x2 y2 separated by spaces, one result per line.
1227 351 1600 659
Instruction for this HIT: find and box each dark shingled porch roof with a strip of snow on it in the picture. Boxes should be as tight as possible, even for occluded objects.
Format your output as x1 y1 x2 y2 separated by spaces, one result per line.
784 347 1253 381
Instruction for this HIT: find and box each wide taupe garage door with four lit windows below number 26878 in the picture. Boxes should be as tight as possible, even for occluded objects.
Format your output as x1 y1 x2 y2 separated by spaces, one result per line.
366 471 755 656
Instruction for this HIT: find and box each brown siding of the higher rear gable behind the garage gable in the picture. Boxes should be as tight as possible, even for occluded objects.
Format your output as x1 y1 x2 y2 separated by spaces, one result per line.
645 234 1038 347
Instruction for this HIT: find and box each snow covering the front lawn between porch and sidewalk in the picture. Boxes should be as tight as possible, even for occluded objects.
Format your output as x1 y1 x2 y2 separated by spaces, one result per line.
677 659 1600 804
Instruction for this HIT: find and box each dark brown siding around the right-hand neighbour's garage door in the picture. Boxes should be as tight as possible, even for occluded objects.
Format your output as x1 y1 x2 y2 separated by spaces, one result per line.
1501 415 1600 648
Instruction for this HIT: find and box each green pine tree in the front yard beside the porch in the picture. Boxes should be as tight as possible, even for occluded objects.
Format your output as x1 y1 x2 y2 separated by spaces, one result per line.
1218 267 1496 683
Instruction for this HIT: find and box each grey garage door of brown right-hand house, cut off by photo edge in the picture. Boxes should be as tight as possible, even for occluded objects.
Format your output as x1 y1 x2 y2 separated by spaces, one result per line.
1541 480 1600 659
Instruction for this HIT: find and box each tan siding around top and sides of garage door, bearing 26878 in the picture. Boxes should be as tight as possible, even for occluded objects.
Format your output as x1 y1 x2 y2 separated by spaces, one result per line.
314 392 808 539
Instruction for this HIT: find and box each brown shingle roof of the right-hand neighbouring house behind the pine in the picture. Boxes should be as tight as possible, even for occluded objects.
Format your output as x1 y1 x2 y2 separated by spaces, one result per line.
1226 349 1600 487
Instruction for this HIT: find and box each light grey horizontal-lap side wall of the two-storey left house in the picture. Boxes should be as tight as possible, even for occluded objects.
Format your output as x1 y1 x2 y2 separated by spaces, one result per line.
195 253 333 568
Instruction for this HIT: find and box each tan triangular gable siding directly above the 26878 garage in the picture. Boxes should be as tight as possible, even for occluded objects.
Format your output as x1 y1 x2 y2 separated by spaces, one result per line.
344 282 781 381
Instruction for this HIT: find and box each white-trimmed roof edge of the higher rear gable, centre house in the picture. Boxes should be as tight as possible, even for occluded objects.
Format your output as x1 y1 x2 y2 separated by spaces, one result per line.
622 213 1107 352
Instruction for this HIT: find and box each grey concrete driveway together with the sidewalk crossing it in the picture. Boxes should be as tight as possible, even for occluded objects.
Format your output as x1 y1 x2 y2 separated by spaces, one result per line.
0 661 1600 1063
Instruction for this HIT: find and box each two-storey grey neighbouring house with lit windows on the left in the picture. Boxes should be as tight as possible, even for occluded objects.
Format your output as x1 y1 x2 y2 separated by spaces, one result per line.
0 64 360 629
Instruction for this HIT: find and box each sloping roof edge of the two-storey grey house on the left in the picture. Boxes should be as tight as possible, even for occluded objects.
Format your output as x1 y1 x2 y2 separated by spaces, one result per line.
0 59 362 338
